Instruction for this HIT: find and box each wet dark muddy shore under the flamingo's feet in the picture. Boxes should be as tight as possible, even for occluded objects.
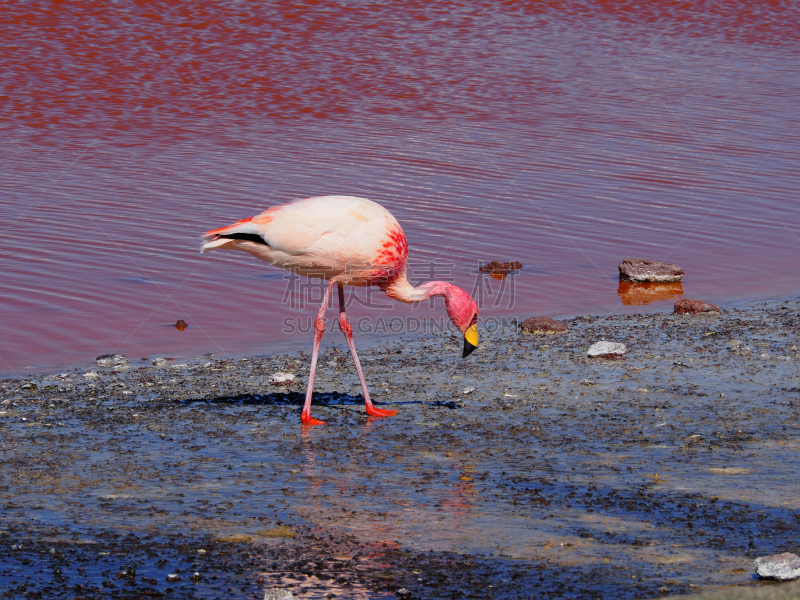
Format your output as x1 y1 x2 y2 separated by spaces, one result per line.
0 300 800 600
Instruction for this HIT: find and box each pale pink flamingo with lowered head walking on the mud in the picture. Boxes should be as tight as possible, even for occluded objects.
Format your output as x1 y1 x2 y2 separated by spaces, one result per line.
201 196 478 426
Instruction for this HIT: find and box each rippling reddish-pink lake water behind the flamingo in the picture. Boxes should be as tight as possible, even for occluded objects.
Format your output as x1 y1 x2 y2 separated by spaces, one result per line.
0 0 800 374
